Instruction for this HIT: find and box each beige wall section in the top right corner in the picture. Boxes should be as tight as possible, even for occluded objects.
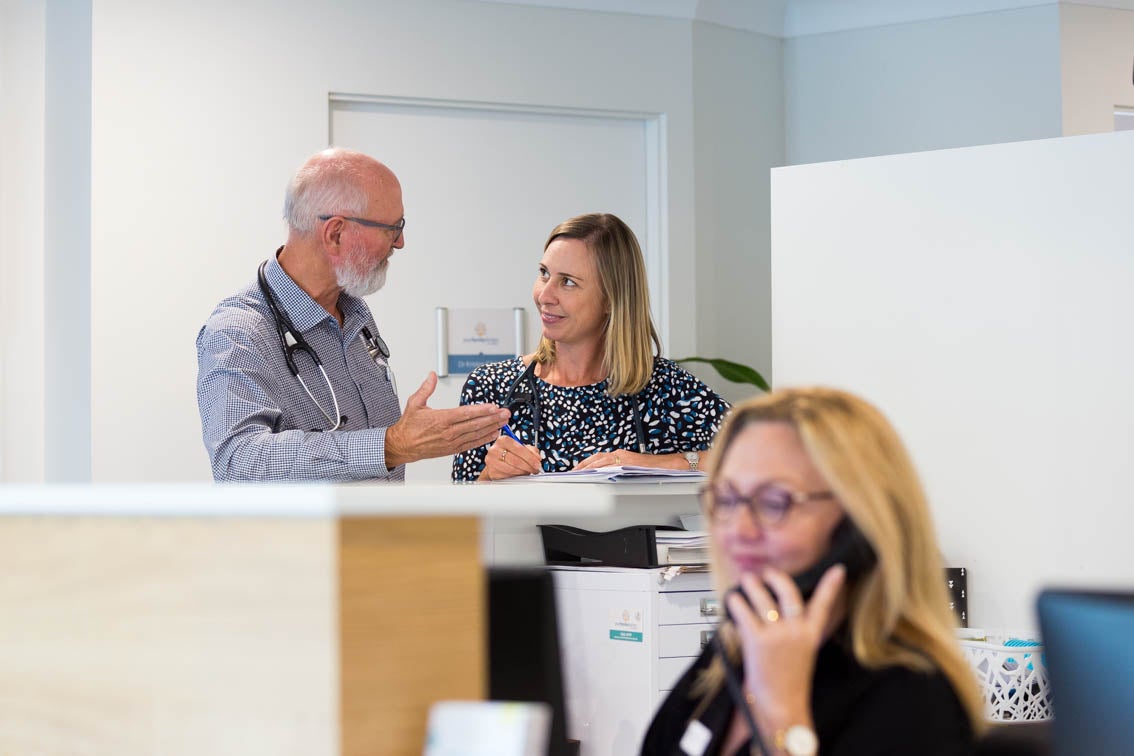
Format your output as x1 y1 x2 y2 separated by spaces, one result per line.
1059 5 1134 136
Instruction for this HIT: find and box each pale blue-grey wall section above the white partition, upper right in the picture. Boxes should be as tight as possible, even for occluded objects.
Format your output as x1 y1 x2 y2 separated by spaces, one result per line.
784 3 1061 163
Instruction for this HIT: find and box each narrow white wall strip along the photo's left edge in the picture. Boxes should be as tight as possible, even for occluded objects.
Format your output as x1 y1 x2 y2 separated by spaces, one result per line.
0 0 46 483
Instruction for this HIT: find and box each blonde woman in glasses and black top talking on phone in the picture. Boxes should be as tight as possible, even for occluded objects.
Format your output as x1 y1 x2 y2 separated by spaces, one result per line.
642 389 983 756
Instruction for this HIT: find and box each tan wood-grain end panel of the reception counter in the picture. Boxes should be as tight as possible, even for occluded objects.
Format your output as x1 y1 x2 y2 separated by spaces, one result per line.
339 517 488 756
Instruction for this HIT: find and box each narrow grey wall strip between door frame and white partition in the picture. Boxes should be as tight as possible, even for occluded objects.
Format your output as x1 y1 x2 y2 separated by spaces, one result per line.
689 23 784 400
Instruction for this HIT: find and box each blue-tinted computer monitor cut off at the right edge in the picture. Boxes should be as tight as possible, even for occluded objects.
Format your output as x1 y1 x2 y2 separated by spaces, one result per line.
1036 589 1134 756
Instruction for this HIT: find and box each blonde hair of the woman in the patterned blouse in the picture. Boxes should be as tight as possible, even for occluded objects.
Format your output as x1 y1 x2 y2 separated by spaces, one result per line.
535 213 661 397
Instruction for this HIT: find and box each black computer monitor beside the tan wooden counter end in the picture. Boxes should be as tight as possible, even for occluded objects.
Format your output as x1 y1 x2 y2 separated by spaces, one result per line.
488 567 578 756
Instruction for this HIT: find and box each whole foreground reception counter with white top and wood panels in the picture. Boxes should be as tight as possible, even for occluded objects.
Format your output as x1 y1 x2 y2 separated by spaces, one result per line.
0 484 617 756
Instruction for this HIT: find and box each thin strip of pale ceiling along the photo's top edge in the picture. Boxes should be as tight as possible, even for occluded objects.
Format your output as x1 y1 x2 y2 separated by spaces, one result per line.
469 0 1134 37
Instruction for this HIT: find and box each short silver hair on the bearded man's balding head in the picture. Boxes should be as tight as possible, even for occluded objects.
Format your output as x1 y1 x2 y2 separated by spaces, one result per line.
284 150 367 233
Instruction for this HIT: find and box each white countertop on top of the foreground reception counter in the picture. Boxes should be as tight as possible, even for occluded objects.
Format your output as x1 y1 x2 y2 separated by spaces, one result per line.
0 483 628 517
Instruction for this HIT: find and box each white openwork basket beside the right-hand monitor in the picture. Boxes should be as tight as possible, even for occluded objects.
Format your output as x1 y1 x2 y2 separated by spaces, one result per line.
959 628 1051 722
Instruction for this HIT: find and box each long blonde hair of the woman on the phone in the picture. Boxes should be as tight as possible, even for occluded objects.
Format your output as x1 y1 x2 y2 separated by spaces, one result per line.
695 388 984 732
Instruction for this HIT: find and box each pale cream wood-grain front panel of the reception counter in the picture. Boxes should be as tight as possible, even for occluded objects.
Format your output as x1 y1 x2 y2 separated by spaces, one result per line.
0 517 339 756
